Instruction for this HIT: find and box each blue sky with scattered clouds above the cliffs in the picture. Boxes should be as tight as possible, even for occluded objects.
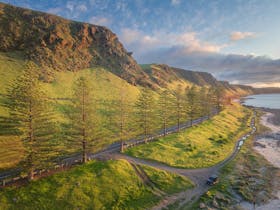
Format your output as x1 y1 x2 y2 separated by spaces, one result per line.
0 0 280 87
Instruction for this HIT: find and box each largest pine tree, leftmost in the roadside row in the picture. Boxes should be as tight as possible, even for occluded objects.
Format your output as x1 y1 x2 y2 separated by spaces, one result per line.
2 62 55 180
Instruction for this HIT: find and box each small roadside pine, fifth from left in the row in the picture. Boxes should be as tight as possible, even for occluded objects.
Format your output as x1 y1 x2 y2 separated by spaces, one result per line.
158 90 174 135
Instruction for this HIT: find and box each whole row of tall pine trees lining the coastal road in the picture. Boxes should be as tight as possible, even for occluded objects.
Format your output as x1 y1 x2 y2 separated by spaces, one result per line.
0 62 223 180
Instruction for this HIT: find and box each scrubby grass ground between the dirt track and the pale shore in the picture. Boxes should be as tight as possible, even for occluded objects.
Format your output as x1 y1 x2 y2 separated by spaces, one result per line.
188 110 280 209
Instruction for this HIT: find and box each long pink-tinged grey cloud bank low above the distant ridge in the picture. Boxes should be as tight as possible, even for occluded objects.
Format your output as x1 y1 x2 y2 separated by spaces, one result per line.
119 28 280 87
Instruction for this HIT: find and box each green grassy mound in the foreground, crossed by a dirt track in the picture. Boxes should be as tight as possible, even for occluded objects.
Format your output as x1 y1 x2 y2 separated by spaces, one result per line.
0 160 192 210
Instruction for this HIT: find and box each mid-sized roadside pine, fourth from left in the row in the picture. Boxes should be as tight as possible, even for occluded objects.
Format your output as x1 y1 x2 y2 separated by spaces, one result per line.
136 88 156 142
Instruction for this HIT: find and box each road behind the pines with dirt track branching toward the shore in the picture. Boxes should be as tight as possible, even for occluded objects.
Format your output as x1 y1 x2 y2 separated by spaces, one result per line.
0 109 256 210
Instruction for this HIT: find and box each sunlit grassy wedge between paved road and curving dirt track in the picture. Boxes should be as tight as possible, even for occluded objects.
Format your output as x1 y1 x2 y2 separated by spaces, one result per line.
126 104 251 168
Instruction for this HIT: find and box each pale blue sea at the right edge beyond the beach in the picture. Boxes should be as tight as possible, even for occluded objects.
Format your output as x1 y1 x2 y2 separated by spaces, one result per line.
244 94 280 109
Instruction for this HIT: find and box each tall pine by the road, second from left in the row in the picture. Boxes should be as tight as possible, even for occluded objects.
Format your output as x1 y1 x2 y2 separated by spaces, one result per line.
68 77 100 163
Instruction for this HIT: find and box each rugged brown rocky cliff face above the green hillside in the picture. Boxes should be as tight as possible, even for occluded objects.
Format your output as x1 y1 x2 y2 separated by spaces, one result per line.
0 3 152 86
